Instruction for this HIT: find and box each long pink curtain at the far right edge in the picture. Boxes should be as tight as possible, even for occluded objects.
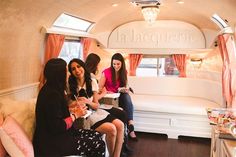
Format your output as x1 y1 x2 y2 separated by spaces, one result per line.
218 34 236 108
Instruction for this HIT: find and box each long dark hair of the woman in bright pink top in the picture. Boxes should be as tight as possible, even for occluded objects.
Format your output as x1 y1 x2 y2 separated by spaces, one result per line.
111 53 127 87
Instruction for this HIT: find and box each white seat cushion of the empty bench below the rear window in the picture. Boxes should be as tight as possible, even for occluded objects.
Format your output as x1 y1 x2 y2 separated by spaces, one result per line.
131 94 220 115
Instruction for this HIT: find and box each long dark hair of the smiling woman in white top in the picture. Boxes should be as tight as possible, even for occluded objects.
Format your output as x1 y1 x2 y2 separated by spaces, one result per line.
68 58 93 99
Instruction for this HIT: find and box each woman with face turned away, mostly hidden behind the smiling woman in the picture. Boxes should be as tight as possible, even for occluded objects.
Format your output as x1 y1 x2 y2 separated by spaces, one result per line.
85 53 132 154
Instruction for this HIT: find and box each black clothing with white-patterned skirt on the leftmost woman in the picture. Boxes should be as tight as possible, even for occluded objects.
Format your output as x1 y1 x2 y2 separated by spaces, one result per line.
33 84 105 157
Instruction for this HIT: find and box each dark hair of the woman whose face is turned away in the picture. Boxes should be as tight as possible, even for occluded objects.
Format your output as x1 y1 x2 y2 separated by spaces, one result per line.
85 53 101 75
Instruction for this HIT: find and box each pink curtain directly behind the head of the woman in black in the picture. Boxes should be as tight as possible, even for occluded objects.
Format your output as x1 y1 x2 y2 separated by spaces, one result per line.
39 34 65 89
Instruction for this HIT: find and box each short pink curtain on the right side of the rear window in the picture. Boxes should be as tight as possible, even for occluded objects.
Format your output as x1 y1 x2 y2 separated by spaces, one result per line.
172 54 187 77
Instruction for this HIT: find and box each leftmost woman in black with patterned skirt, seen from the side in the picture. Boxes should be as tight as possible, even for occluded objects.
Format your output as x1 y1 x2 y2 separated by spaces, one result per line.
33 58 105 157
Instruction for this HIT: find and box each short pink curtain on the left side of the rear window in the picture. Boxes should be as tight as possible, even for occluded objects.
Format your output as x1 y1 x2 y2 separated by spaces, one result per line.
129 54 143 76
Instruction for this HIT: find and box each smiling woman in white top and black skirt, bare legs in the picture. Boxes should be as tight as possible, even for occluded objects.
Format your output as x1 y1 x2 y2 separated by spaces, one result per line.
68 59 124 157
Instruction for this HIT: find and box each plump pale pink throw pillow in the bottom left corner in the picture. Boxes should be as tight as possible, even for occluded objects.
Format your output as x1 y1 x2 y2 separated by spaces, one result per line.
0 116 34 157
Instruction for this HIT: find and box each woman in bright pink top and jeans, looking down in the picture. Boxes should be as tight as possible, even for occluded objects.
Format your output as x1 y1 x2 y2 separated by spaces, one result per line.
99 53 137 141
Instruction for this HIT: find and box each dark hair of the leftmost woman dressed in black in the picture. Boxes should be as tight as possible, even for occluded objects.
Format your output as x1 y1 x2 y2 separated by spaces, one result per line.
44 58 67 93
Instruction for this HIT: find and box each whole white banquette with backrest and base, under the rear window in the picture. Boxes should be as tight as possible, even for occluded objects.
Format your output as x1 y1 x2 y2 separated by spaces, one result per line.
128 77 224 138
